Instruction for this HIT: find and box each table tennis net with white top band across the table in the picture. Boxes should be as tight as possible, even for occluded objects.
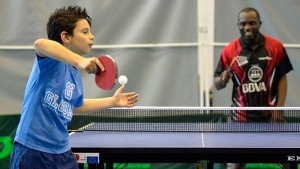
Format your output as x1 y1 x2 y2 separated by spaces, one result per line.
68 107 300 132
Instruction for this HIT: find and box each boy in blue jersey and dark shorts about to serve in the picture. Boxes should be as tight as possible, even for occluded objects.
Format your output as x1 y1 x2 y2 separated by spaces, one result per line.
10 6 138 169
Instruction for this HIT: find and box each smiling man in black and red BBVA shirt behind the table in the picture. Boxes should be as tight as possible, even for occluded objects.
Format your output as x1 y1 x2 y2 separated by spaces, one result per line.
214 8 293 122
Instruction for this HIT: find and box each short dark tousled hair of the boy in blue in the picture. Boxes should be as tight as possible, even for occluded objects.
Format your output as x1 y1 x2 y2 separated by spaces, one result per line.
47 6 92 44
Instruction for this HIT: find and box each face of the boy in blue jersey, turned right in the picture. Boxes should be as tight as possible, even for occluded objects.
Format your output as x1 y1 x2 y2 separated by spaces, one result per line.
66 19 95 55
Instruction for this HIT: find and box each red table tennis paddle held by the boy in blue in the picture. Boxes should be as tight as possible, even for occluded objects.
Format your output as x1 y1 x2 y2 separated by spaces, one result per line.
95 55 118 90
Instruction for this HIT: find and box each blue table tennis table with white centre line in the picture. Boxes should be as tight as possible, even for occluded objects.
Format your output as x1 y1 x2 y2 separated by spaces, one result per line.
70 124 300 169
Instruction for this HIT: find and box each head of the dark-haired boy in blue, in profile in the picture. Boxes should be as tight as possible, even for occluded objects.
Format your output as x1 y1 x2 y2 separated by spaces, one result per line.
47 6 94 55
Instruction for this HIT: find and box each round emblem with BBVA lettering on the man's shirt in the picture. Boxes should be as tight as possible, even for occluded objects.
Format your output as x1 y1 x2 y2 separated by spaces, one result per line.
242 65 267 93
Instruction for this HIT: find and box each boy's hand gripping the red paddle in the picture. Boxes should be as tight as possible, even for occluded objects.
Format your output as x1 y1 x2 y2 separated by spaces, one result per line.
78 57 105 74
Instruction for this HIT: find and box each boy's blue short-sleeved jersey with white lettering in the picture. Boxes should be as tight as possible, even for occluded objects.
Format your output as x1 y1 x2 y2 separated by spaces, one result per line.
15 55 83 154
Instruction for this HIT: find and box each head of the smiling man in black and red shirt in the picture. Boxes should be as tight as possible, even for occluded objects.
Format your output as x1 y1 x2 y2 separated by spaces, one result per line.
237 7 262 46
